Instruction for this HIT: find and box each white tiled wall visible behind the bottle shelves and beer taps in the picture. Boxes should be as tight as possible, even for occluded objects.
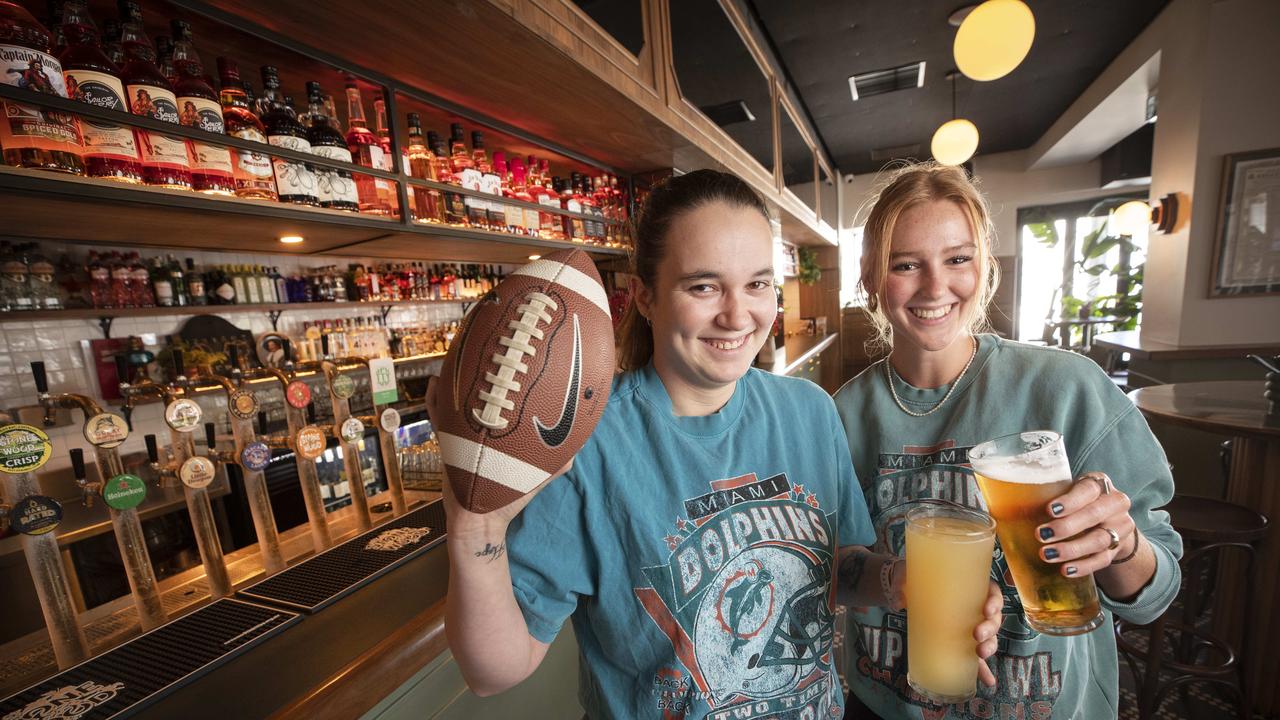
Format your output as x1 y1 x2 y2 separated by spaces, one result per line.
0 242 462 484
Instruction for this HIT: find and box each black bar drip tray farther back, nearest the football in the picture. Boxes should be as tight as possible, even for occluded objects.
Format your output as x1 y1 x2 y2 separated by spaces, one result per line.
236 500 444 612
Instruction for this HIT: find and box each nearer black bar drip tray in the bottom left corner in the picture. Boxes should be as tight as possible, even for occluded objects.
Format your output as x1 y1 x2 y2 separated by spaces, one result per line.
0 598 300 720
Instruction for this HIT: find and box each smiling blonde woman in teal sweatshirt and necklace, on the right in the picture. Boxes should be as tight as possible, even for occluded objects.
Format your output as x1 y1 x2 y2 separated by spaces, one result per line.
836 163 1181 719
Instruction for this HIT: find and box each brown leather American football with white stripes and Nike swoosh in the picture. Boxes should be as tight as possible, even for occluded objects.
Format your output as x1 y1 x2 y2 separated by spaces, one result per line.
433 250 613 512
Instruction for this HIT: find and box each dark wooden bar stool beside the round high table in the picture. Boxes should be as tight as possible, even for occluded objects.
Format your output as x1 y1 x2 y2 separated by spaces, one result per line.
1115 495 1268 720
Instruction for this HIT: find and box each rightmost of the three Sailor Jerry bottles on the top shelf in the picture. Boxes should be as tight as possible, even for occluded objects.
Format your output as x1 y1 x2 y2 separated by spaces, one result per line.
170 20 236 196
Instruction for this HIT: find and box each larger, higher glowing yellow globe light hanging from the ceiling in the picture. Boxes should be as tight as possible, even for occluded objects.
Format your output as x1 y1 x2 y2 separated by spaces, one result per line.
954 0 1036 81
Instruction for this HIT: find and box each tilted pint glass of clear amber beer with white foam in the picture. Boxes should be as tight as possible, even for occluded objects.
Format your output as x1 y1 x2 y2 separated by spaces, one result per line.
969 430 1102 635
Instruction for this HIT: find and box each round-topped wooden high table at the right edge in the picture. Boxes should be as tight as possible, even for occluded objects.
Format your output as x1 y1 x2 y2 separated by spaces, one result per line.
1129 380 1280 717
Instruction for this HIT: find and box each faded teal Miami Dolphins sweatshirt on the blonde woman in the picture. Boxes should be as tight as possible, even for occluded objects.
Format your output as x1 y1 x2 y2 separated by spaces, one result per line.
836 334 1183 720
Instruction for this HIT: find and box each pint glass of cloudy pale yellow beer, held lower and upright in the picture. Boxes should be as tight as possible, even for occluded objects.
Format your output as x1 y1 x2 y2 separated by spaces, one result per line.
906 502 996 703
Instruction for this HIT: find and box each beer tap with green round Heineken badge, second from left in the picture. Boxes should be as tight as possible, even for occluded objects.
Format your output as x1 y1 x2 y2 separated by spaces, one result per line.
31 361 169 630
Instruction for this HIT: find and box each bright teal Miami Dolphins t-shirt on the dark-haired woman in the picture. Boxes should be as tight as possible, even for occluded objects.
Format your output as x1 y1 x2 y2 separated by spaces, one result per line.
508 365 874 720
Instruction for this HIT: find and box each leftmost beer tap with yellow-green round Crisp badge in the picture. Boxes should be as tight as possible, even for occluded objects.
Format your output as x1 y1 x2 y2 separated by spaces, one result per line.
0 413 90 670
